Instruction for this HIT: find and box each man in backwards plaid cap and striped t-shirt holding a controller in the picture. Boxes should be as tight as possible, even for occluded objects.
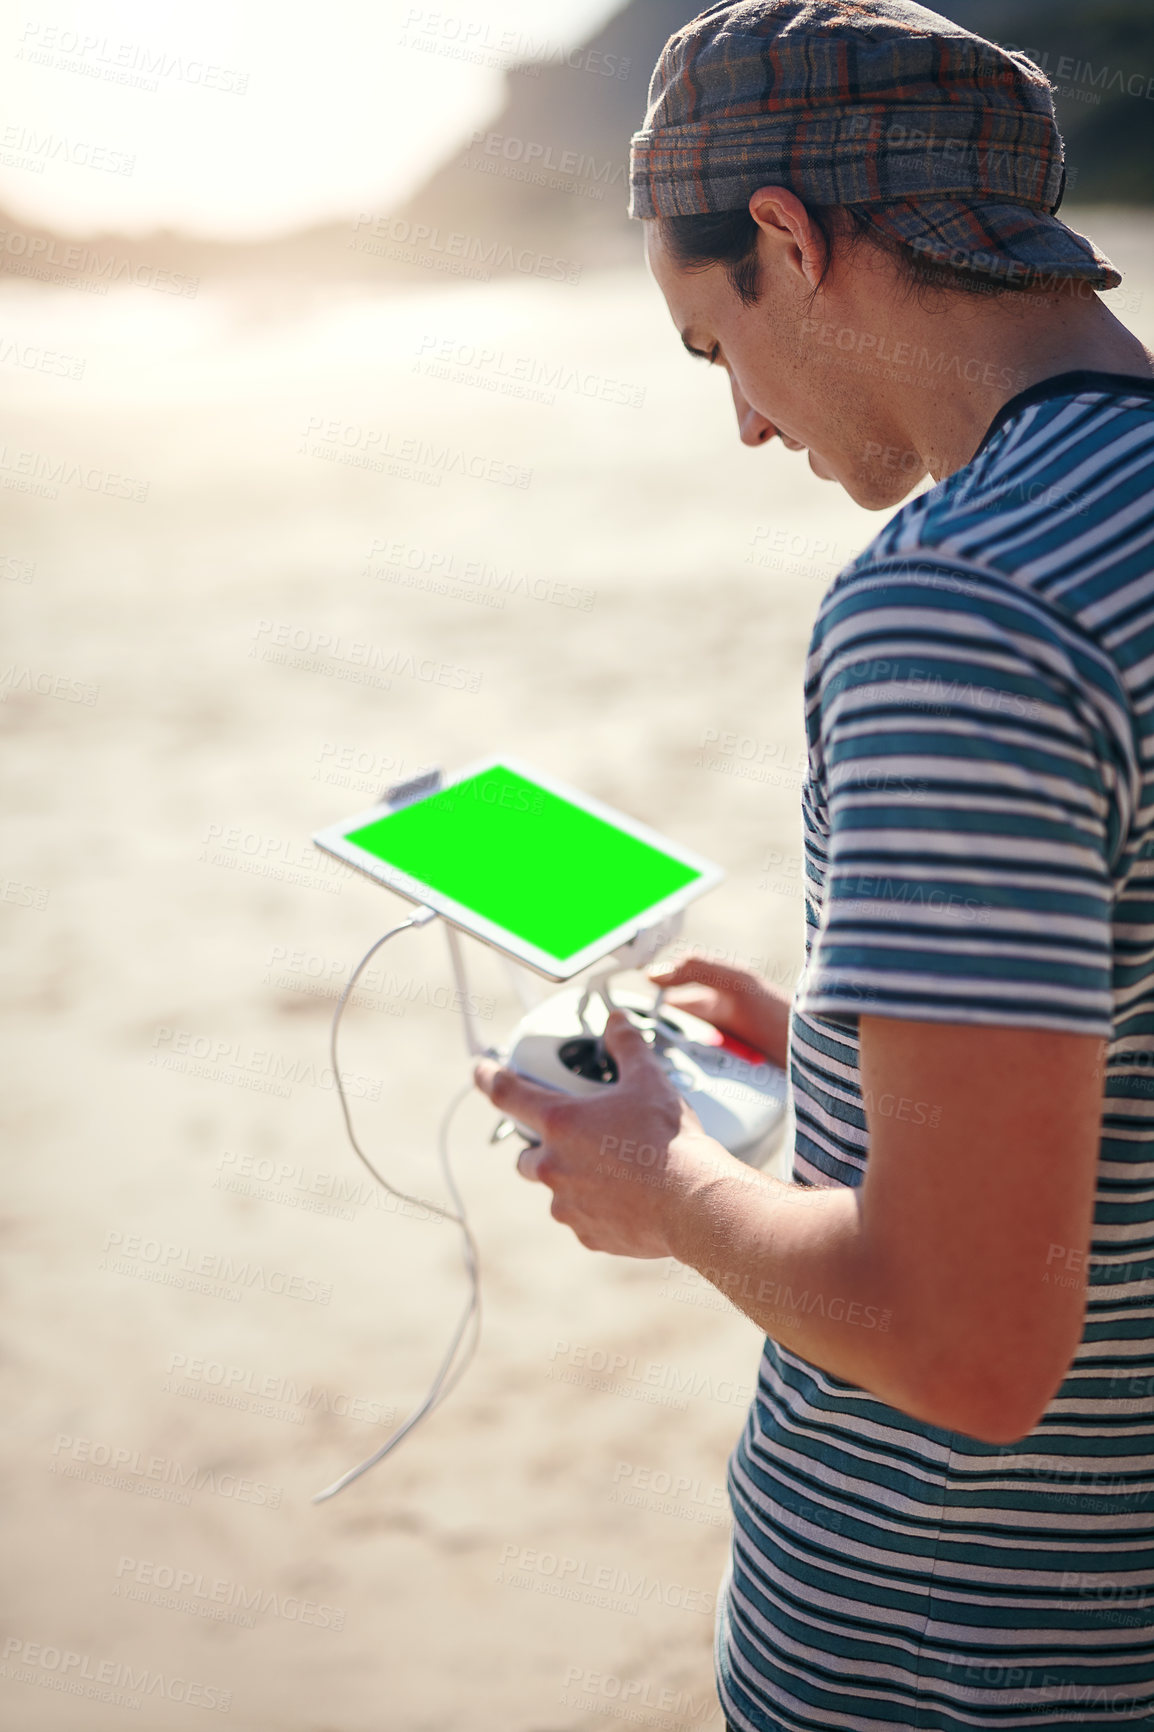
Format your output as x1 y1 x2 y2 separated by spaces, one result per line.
478 0 1154 1732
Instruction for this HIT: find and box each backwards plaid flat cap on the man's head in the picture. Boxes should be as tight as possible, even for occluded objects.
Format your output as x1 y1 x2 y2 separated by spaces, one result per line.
629 0 1121 289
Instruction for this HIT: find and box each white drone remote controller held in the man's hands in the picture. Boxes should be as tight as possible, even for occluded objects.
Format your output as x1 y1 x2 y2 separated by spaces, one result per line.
506 987 788 1167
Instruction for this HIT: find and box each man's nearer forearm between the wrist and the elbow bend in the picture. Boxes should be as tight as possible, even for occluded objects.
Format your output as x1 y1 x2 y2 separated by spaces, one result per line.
671 1150 936 1424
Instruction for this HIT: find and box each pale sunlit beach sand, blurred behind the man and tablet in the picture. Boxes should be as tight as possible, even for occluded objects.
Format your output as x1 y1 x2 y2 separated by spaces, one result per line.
0 3 1154 1732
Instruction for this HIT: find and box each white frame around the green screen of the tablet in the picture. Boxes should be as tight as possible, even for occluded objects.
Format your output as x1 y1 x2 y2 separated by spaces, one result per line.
312 752 724 980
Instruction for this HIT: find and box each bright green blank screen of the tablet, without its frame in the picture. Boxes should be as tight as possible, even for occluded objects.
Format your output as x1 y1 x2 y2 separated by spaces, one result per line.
348 764 702 961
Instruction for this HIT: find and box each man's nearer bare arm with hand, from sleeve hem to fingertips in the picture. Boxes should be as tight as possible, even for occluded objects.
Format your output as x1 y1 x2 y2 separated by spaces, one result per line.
477 983 1104 1443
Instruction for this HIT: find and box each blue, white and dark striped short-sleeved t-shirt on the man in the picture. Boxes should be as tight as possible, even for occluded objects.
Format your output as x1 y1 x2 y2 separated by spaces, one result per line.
717 372 1154 1732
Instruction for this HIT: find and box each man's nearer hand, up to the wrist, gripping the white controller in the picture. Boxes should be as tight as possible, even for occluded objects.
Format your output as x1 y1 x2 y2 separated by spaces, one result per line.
475 1010 747 1257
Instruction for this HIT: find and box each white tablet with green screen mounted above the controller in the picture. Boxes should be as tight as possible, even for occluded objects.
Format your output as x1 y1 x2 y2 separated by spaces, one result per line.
314 757 724 980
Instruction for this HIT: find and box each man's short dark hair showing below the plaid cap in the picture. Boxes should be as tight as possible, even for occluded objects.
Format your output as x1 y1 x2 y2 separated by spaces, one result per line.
658 204 1029 307
